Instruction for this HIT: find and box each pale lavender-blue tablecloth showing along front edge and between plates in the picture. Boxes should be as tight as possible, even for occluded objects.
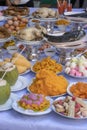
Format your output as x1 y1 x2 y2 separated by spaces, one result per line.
0 6 87 130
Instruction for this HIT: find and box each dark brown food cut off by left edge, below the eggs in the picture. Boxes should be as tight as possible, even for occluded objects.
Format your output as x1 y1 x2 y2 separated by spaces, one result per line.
0 27 11 41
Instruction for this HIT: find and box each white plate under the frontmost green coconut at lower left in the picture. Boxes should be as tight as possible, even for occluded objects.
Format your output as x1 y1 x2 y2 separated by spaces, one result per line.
0 93 17 111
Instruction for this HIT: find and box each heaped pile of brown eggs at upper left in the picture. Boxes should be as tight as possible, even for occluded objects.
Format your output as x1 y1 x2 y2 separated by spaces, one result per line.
4 15 28 35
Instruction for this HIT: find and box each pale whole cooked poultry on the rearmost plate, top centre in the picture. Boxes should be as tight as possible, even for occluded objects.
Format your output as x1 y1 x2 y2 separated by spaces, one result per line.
32 7 57 19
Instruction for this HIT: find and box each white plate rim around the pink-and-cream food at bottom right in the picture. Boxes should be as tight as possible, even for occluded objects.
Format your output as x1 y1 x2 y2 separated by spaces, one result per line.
52 96 87 120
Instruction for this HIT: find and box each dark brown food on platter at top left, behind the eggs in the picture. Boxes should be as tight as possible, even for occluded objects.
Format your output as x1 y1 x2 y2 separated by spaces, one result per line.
2 6 29 17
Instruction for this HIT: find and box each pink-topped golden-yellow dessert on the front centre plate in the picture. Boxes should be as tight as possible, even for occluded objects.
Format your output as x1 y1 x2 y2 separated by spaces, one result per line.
18 93 50 112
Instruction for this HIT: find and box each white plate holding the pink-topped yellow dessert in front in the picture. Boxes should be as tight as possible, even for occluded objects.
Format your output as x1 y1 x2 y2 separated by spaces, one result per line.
12 97 53 116
